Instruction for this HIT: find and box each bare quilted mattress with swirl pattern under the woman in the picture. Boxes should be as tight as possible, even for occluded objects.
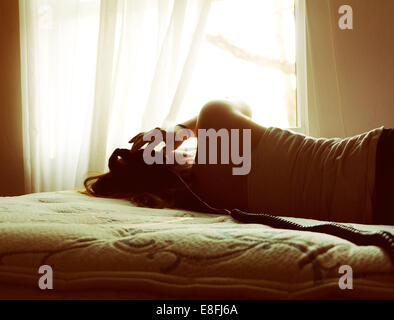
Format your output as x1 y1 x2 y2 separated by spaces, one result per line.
0 191 394 299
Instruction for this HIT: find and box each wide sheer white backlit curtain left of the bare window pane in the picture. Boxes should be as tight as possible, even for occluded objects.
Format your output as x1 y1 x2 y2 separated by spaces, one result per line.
19 0 212 192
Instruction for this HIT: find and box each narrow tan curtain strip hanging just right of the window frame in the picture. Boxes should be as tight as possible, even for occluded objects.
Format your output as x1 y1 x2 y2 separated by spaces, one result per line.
303 0 349 137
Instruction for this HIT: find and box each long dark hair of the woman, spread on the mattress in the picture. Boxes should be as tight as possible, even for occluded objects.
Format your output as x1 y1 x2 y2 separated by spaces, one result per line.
84 149 201 210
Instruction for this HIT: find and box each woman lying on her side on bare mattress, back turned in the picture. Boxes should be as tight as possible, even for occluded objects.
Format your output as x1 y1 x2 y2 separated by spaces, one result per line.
85 98 394 224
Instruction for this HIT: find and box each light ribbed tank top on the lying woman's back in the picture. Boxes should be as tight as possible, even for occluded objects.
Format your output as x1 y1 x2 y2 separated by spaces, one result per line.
248 127 383 224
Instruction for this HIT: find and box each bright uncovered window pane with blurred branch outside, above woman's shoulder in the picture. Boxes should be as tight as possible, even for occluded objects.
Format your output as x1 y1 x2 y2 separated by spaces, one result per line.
178 0 298 127
